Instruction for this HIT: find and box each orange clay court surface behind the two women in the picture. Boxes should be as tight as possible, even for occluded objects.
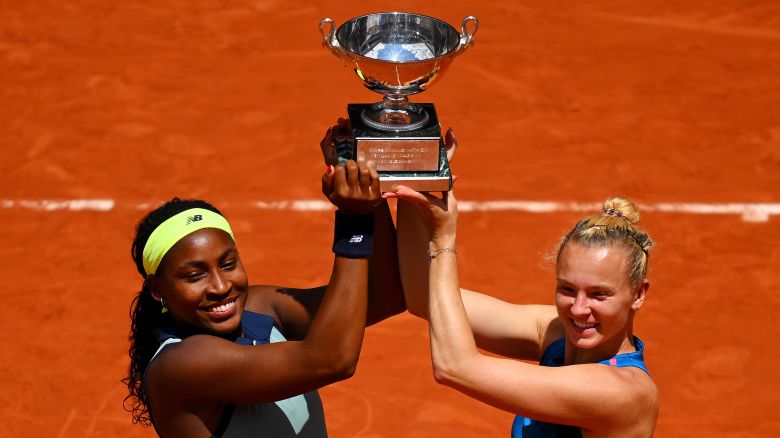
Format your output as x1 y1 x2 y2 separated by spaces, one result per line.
0 0 780 438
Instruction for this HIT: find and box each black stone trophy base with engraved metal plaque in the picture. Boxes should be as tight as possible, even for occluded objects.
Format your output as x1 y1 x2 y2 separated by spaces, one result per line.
336 103 452 192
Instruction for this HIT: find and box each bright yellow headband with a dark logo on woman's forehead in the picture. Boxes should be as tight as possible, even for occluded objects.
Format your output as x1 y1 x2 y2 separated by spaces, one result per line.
143 208 235 275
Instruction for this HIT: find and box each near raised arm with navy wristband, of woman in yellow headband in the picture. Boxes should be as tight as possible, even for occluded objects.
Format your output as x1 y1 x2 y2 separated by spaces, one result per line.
148 162 380 407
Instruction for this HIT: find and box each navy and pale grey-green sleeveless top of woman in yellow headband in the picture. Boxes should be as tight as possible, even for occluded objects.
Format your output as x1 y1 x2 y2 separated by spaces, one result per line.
146 310 328 438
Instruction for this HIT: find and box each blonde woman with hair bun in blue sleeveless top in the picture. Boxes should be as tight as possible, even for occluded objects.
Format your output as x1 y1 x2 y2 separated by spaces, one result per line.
384 186 658 438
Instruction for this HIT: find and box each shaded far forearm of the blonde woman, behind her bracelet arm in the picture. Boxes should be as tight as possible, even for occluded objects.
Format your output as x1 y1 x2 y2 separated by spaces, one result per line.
398 199 430 318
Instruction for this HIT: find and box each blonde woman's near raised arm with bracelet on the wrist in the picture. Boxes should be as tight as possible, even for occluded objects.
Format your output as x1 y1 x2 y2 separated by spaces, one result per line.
398 188 652 430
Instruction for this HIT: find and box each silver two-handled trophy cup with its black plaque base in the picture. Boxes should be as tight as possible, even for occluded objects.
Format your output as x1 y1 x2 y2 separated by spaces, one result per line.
320 12 479 191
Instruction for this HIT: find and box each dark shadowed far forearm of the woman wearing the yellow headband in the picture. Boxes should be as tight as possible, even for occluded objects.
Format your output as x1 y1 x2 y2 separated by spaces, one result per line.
366 201 406 325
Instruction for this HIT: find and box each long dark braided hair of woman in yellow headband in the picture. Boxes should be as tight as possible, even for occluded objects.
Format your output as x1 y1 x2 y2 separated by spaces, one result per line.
122 198 222 426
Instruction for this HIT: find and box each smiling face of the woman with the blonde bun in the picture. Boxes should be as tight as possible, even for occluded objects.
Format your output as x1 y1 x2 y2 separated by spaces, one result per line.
555 242 648 349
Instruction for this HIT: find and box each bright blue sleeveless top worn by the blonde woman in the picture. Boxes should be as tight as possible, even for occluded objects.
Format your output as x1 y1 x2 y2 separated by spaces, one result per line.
512 336 650 438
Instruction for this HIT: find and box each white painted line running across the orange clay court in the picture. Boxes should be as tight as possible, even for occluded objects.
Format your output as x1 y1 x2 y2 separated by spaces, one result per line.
0 199 780 222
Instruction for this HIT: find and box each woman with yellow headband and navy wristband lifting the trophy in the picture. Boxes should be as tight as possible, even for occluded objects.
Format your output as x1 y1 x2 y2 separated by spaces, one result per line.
126 130 405 438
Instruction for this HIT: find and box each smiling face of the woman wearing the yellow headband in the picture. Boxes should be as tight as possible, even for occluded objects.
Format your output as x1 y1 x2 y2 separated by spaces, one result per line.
151 228 248 336
